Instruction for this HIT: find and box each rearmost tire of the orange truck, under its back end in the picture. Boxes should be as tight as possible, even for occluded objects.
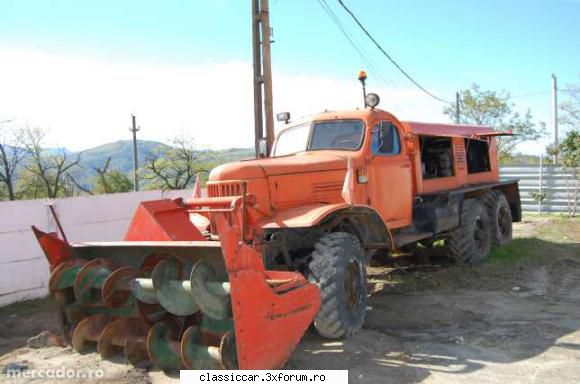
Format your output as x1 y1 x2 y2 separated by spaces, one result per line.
481 189 512 246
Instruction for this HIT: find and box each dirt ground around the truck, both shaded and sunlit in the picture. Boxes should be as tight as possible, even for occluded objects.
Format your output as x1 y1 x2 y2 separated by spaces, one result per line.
0 215 580 384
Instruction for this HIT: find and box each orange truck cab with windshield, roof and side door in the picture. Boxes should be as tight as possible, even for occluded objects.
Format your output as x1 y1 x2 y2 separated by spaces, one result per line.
272 109 414 228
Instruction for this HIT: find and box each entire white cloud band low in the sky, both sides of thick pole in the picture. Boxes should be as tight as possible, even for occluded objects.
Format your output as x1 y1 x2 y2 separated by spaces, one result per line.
0 50 524 153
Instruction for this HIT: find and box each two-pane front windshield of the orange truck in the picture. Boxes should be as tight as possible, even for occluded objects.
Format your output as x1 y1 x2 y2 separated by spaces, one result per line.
274 120 364 156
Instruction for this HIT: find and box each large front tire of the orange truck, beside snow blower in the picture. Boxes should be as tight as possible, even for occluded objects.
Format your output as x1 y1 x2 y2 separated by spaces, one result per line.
308 232 367 339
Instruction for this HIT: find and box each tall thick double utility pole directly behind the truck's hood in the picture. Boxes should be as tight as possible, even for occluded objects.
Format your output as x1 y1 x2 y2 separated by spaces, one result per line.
252 0 274 157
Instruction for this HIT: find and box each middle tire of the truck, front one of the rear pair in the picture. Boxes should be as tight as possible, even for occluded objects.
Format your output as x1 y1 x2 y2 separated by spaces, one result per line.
447 199 491 264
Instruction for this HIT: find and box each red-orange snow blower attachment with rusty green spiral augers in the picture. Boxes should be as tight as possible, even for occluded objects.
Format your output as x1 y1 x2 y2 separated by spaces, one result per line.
33 194 320 370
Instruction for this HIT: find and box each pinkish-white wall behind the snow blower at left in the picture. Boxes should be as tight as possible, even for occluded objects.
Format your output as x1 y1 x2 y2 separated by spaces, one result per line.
0 190 191 306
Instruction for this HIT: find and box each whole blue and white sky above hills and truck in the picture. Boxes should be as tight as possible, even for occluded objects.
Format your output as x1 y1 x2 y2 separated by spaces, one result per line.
0 0 580 154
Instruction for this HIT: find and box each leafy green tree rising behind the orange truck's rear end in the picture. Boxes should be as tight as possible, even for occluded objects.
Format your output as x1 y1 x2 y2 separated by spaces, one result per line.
443 84 545 162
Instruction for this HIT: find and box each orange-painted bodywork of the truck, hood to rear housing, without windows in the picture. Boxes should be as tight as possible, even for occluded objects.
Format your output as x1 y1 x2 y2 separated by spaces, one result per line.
208 109 499 229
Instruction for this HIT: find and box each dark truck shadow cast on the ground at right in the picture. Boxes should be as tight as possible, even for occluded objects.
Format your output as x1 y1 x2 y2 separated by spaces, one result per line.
290 238 580 383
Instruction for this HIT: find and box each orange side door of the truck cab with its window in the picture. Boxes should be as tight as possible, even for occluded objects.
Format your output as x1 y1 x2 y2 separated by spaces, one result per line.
369 121 413 229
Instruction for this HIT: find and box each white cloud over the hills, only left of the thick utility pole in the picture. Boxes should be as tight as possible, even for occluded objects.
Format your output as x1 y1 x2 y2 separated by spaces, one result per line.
0 51 252 152
